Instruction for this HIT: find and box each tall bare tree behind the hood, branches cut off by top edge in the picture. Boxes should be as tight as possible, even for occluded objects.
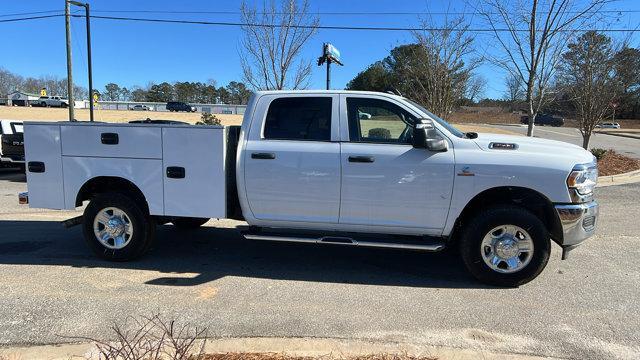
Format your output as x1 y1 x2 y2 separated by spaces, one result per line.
479 0 611 136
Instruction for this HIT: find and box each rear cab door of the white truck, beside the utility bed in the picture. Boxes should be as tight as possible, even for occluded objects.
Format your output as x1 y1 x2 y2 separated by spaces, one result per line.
243 94 340 223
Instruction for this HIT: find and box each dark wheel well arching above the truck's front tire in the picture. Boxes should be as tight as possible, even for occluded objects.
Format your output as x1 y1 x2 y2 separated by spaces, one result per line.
451 186 563 242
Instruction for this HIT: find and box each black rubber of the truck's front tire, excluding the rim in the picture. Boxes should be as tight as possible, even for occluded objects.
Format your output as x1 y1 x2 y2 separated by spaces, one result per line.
460 206 551 287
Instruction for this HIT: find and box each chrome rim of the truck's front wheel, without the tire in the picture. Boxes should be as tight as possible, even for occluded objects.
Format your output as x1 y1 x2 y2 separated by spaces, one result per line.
480 225 533 274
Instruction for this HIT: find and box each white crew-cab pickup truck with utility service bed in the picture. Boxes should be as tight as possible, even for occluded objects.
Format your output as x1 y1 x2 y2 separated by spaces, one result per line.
20 91 598 286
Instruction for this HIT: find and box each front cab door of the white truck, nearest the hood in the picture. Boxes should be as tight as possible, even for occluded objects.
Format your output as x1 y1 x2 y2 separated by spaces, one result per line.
340 95 454 234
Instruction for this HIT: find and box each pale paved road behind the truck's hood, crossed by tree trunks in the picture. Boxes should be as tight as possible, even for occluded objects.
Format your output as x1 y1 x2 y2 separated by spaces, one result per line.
488 125 640 159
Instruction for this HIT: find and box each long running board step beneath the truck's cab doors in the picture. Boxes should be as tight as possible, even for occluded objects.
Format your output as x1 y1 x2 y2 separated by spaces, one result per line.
243 233 445 252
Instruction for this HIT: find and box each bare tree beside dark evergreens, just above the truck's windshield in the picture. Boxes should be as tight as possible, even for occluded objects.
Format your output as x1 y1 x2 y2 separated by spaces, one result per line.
410 17 480 116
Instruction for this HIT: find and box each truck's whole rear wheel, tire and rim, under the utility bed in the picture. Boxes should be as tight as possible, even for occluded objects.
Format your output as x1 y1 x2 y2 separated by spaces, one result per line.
82 192 155 261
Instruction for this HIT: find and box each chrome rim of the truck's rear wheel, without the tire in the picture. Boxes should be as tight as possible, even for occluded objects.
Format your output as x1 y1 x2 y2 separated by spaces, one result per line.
93 207 133 250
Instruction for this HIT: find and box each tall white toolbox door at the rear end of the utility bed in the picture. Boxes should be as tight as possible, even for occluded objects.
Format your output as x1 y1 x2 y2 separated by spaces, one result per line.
24 123 65 209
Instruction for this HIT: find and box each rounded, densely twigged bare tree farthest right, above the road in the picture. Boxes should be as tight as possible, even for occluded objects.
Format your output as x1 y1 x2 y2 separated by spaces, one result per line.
559 31 618 149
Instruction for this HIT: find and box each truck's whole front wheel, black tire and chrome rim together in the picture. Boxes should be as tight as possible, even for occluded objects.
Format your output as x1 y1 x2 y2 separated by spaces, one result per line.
460 205 551 287
